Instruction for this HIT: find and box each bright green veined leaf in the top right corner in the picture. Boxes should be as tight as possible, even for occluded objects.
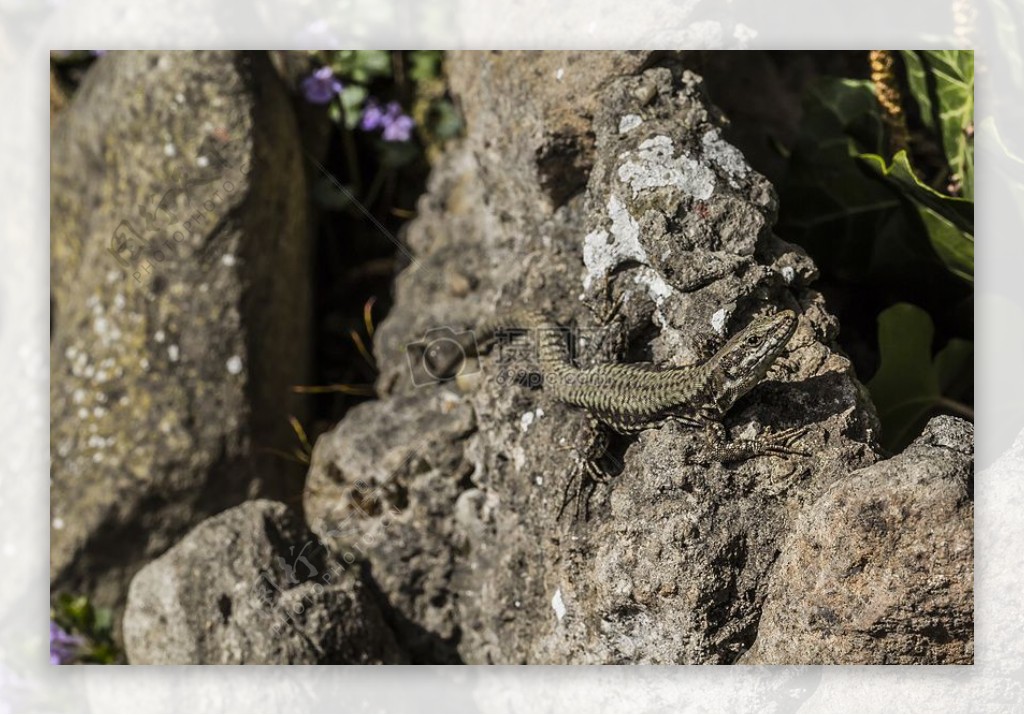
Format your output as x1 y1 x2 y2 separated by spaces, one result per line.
902 50 974 200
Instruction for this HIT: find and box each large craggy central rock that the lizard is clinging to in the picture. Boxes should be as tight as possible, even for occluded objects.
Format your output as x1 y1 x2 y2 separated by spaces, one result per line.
305 52 970 663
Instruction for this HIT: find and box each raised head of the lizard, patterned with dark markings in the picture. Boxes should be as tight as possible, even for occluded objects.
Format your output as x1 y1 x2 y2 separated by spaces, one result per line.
711 310 797 413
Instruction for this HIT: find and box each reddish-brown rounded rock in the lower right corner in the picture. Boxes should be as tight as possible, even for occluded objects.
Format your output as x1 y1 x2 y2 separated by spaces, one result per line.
742 417 974 665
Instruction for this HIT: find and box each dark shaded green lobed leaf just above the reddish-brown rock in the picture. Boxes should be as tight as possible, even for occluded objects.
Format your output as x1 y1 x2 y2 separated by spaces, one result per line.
867 303 974 452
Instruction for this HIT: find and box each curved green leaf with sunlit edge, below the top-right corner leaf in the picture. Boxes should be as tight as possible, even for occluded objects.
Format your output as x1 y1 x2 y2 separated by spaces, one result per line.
858 151 974 284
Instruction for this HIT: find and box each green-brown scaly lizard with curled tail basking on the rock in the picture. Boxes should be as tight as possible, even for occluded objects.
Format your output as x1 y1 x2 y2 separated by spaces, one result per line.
424 309 807 518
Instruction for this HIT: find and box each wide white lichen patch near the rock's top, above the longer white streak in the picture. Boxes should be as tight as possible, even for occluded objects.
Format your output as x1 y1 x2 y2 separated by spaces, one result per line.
618 135 715 200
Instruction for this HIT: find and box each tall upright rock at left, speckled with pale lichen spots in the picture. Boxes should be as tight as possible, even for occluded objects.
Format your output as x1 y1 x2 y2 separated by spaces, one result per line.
50 52 310 622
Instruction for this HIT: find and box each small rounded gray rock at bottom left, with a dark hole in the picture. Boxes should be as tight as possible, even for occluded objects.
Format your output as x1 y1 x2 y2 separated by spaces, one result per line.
124 500 406 665
